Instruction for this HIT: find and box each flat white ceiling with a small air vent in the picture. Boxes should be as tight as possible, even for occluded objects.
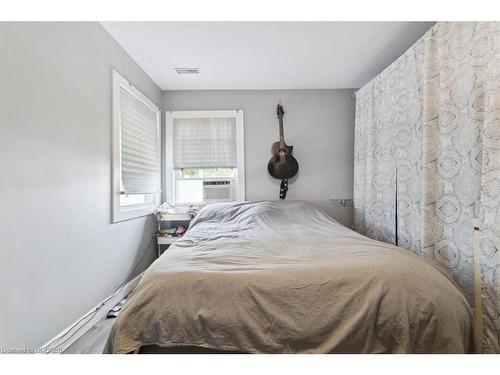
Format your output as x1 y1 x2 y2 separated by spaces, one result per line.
102 22 434 90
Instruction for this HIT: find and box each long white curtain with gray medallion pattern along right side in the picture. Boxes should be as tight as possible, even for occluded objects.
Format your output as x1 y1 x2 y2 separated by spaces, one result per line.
354 22 500 353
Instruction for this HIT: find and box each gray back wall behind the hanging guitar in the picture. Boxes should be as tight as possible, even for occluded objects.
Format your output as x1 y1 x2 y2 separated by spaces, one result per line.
162 90 355 226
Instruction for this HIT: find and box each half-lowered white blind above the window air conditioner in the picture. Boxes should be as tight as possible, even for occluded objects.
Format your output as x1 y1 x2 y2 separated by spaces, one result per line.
173 117 238 169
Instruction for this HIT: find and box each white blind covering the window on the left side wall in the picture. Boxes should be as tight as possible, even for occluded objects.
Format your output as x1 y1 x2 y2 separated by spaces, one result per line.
120 87 161 195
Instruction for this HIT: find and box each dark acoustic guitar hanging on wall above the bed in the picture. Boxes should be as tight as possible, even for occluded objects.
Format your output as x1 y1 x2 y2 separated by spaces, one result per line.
267 101 299 199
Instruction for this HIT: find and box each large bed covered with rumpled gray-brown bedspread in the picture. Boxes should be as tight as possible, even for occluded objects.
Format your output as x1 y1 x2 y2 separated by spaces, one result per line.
105 201 472 353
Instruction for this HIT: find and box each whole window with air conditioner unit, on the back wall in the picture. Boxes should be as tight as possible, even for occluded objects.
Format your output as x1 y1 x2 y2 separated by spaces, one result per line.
165 110 245 205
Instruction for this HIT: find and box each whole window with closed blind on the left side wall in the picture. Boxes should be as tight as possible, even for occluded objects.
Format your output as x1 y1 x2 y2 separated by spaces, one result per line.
113 71 161 222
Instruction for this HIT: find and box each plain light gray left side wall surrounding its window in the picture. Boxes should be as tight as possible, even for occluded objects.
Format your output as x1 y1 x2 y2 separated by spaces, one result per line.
0 22 161 348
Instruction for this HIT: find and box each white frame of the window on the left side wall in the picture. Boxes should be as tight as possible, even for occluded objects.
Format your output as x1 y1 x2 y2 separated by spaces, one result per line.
111 69 161 223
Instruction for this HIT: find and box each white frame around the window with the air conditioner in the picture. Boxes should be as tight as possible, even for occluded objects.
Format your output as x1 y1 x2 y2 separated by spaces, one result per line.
164 109 245 206
